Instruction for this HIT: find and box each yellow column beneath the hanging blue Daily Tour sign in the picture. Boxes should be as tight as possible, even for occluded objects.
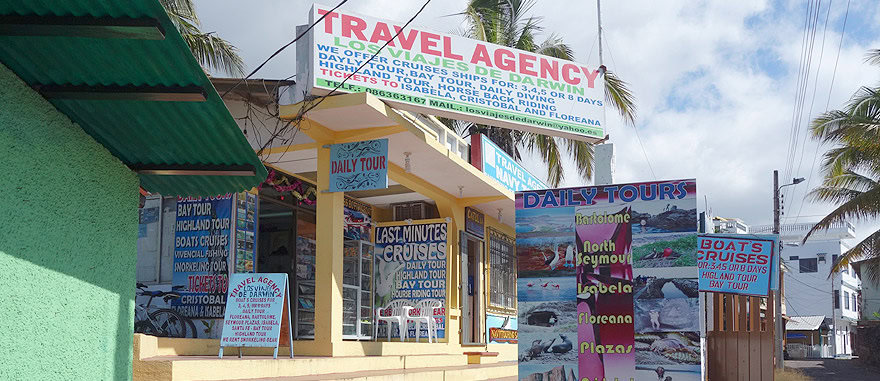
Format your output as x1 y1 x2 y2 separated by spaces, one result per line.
315 147 344 356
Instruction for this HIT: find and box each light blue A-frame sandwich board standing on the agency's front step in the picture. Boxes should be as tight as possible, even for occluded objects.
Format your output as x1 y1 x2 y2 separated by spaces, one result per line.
220 273 293 358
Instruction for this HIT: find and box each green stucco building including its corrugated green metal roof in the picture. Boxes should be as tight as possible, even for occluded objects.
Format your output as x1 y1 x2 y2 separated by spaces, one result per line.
0 0 266 380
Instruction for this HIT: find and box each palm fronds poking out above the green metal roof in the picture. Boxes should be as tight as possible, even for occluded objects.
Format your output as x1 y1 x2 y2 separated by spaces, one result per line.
159 0 244 77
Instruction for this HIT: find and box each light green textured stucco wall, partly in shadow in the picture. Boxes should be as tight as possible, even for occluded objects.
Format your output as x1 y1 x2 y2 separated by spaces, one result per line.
0 64 138 380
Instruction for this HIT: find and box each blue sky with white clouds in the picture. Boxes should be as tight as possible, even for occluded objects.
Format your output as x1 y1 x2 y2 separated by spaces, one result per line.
195 0 880 243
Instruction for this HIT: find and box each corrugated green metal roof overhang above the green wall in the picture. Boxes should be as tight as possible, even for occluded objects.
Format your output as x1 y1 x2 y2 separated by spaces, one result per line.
0 0 267 195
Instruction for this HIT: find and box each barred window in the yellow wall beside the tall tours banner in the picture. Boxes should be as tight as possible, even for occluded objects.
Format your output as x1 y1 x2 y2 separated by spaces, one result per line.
486 228 516 309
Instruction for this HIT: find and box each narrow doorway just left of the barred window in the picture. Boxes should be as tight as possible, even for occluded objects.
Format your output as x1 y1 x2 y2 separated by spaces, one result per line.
459 231 485 345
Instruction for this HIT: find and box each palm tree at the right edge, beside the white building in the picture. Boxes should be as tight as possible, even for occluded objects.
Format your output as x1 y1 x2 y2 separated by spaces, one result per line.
804 49 880 282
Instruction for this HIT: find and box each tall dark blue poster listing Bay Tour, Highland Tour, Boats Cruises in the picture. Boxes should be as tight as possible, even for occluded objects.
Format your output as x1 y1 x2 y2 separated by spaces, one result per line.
171 194 234 337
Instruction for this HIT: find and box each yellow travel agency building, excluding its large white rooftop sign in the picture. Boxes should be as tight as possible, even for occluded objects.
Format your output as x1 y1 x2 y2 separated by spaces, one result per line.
136 91 524 377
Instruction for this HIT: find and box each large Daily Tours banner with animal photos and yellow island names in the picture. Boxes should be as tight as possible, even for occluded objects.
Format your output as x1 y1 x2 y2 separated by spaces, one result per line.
516 180 701 381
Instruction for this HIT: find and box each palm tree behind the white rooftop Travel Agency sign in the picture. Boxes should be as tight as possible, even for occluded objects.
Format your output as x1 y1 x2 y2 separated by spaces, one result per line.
449 0 635 187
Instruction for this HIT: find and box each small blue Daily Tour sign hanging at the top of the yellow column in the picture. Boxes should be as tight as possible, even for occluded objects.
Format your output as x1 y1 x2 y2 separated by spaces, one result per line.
330 139 388 192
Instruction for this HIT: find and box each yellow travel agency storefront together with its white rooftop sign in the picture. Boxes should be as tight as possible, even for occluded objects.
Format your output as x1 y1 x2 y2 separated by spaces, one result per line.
136 5 604 379
